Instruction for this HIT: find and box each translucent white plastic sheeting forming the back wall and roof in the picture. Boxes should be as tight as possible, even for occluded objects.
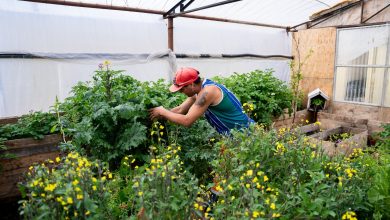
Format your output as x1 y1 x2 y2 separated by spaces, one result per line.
0 0 335 117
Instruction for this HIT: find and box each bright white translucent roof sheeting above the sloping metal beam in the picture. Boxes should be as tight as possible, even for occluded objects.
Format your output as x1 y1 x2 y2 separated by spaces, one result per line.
27 0 340 27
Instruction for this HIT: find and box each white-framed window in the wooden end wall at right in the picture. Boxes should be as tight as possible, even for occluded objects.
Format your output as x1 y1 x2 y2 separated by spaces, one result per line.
334 25 390 107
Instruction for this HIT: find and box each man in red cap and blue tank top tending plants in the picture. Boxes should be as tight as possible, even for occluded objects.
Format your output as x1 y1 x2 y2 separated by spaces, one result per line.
149 67 253 134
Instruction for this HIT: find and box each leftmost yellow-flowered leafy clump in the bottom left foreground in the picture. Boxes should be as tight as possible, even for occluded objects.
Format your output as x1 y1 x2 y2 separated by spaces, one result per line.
19 152 112 219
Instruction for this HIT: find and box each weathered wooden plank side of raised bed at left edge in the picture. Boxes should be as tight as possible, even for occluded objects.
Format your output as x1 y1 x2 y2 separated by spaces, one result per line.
0 134 62 200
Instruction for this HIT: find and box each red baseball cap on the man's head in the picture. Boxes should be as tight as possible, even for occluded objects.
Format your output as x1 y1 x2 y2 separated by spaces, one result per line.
169 67 199 92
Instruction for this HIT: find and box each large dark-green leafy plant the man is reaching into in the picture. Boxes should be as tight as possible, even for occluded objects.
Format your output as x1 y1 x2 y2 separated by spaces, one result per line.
59 62 215 173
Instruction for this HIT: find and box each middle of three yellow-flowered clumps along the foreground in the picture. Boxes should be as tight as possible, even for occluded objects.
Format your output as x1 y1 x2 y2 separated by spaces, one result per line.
106 145 198 219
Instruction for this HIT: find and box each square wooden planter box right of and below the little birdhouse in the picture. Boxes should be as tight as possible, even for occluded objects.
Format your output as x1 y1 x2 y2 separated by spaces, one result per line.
309 126 368 156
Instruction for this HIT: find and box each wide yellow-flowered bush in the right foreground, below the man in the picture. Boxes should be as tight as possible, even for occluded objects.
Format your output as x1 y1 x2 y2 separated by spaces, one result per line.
207 126 374 219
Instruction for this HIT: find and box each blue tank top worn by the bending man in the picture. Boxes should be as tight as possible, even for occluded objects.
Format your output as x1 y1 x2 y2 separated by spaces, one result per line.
202 79 254 134
